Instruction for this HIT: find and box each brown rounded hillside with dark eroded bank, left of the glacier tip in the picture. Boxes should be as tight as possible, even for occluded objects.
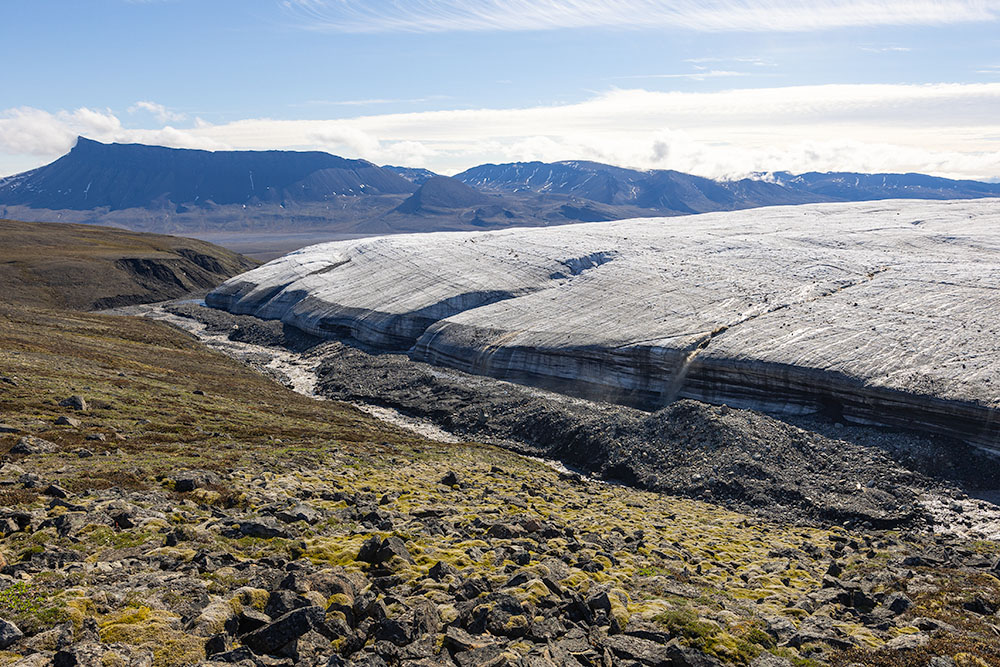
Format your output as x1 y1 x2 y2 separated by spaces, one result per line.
0 220 256 310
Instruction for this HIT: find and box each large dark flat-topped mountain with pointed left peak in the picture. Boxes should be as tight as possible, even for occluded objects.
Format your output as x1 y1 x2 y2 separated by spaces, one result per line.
0 137 416 211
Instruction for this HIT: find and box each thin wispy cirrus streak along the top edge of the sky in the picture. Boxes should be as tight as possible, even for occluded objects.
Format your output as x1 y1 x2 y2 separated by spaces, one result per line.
281 0 1000 33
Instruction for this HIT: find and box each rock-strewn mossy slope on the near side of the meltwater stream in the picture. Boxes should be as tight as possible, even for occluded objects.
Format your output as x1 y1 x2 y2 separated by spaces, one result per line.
0 298 1000 667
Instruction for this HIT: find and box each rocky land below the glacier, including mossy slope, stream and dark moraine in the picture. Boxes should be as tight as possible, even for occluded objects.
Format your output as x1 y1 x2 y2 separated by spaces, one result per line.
0 219 1000 667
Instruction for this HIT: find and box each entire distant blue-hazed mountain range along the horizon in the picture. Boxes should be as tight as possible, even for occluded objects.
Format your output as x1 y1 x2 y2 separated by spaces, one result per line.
0 137 1000 247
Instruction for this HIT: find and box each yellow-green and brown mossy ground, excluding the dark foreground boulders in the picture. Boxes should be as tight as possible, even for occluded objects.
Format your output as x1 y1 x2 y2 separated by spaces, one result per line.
0 305 1000 665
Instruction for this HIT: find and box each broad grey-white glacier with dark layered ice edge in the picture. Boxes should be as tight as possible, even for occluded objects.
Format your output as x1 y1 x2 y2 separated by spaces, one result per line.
206 199 1000 445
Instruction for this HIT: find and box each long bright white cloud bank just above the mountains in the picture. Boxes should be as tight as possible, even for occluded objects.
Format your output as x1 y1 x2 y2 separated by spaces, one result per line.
0 83 1000 179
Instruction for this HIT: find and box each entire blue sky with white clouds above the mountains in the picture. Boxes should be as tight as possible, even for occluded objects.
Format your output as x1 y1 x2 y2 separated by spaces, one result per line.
0 0 1000 178
